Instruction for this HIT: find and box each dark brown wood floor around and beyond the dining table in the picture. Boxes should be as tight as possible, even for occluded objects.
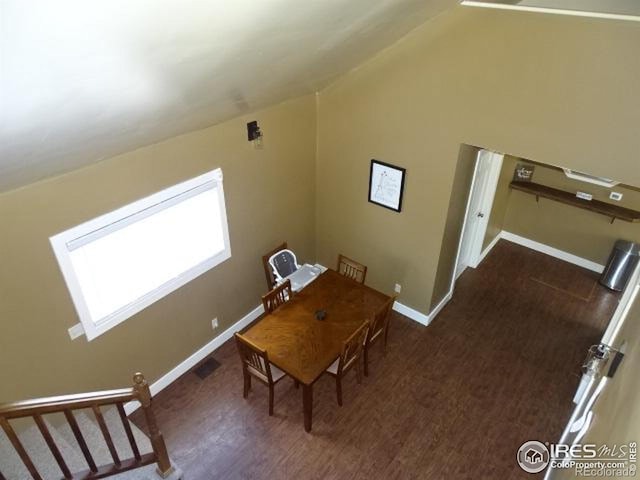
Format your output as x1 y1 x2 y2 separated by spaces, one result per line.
133 241 618 480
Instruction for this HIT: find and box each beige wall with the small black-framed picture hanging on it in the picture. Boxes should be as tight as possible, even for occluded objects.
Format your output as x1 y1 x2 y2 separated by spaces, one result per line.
316 7 640 312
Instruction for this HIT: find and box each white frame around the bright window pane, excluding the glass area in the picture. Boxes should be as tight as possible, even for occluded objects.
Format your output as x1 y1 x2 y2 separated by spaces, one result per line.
49 168 231 341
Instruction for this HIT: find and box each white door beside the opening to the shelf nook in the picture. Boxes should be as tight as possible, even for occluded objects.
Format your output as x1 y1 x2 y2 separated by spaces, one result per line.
455 150 504 278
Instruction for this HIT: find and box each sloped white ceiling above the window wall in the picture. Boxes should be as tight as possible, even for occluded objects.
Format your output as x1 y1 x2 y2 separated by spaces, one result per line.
0 0 457 192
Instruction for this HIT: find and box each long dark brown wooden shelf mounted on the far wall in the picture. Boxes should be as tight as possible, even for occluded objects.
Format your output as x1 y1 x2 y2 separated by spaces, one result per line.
509 181 640 223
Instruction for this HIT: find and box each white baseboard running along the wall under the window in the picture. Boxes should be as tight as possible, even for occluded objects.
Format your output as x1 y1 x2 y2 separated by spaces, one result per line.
124 305 264 415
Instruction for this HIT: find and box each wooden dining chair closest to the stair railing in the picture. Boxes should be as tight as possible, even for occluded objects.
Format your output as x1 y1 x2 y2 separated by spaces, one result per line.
235 332 286 415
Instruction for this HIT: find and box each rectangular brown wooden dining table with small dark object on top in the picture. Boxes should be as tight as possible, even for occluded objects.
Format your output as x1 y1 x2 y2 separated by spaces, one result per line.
244 270 390 432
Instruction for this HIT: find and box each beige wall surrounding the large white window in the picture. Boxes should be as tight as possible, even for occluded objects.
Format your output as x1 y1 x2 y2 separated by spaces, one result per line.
0 96 316 401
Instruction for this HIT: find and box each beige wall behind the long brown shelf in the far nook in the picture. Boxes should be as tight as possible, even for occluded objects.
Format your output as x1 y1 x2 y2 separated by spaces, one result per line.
503 165 640 265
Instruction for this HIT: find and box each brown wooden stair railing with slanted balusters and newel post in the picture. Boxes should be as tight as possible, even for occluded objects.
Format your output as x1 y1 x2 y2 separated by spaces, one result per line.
0 373 174 480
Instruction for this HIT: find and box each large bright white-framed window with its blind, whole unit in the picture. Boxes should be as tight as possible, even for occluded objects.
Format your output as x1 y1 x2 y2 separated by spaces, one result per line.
50 169 231 340
